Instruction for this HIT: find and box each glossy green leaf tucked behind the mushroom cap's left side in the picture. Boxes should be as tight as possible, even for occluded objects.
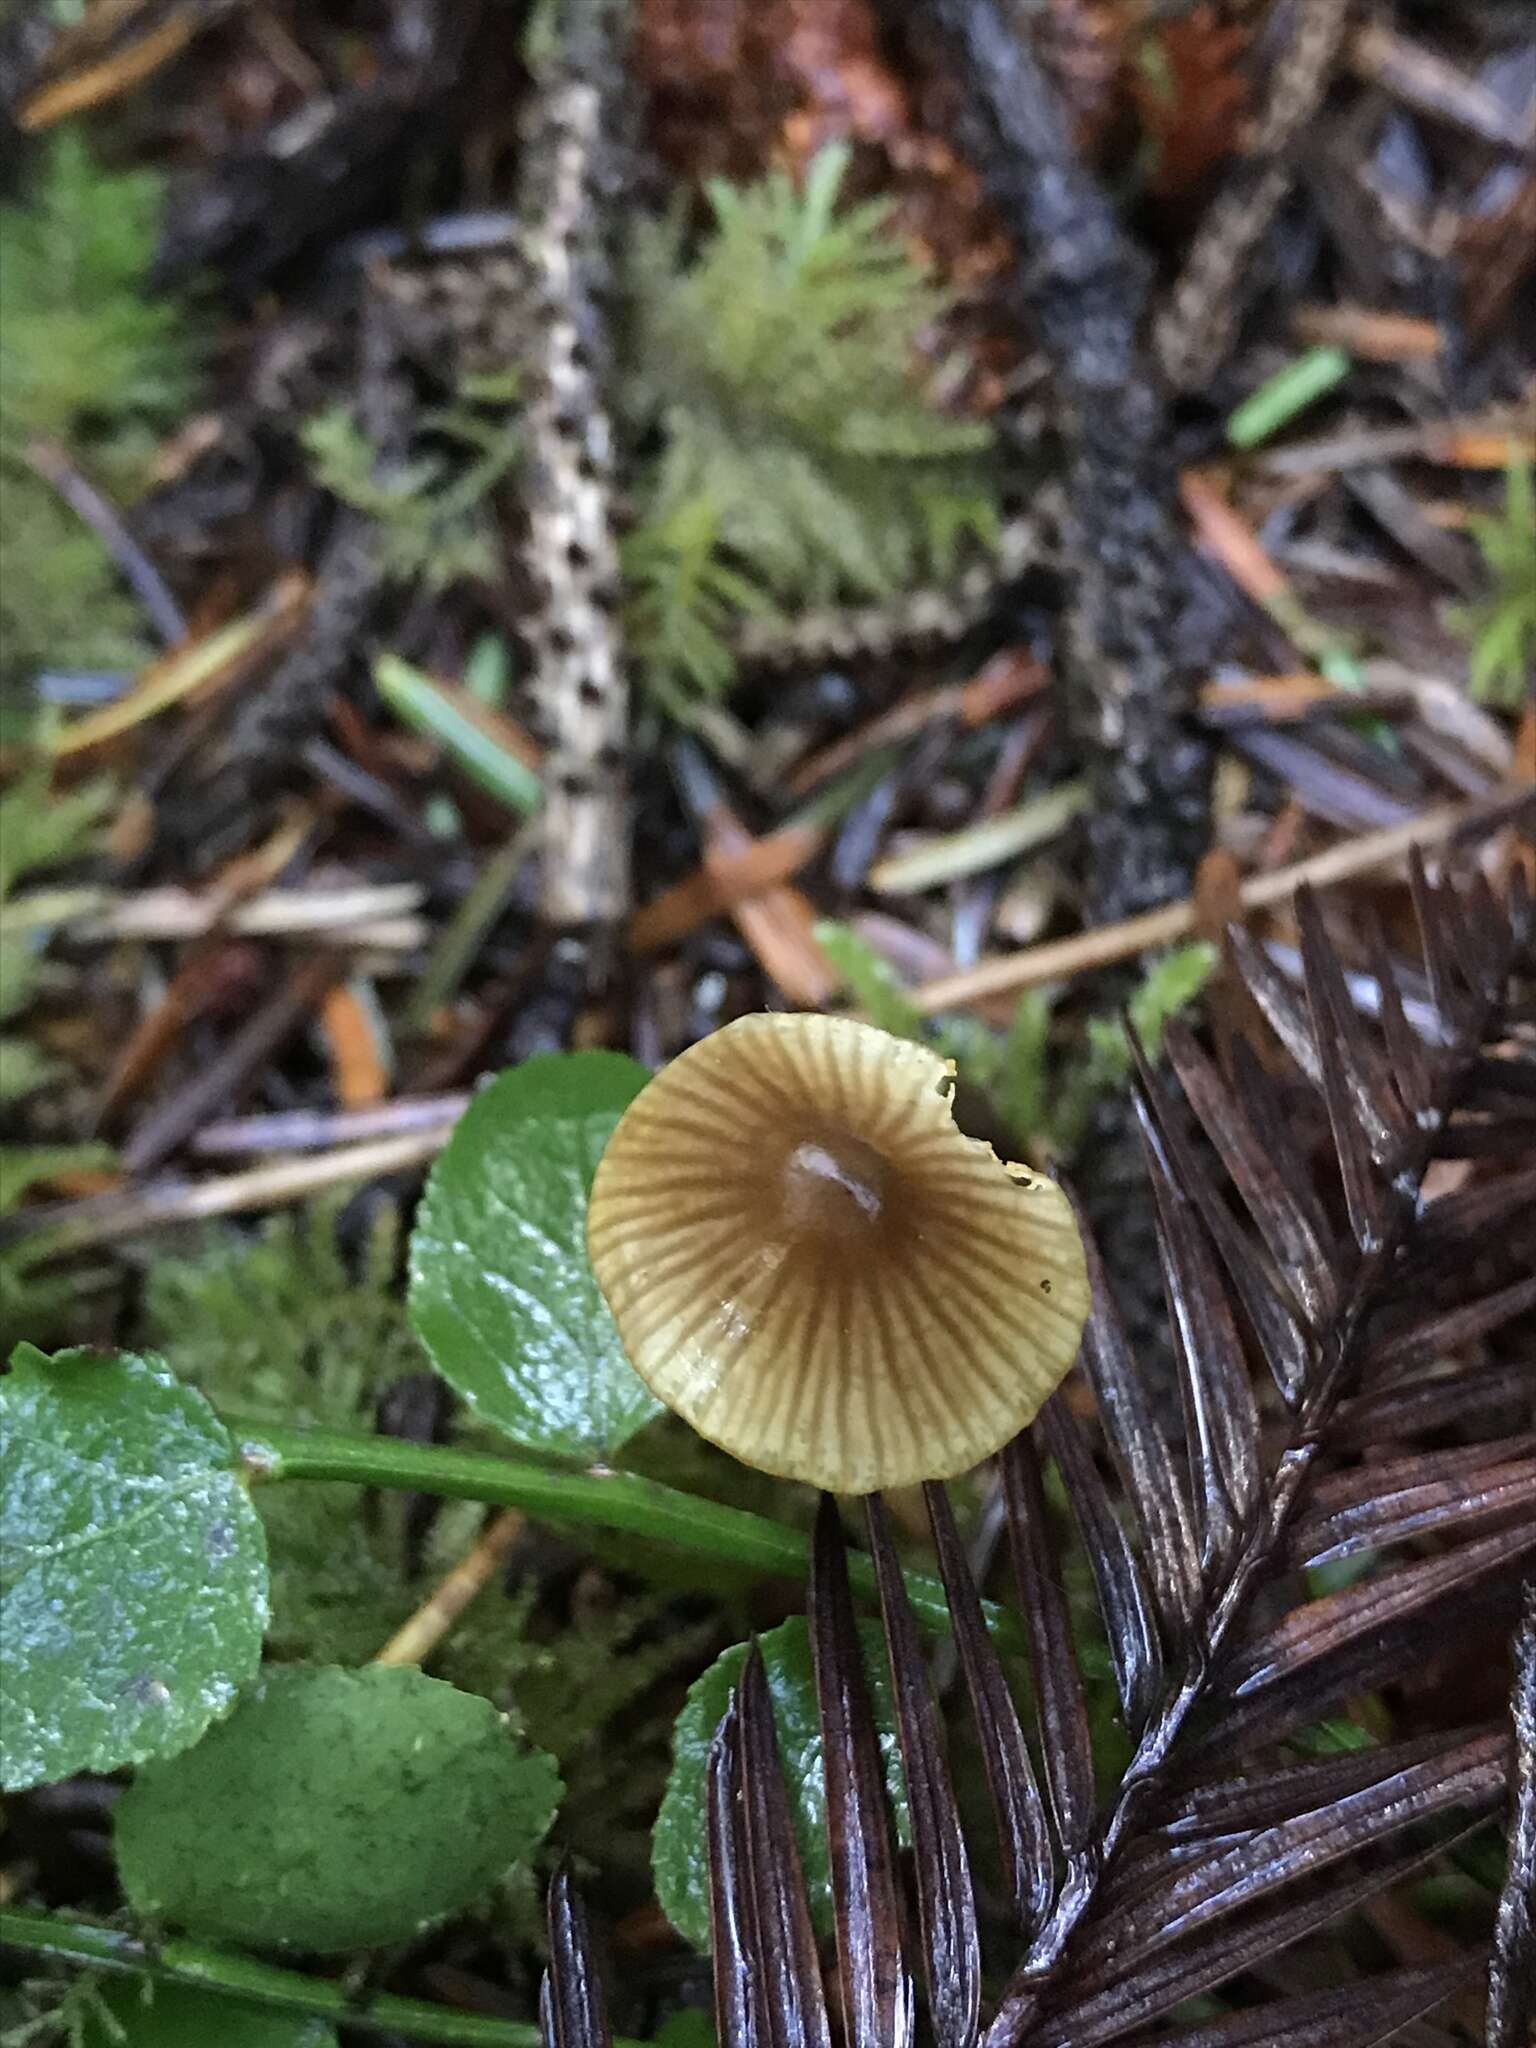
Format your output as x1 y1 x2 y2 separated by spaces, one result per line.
410 1053 659 1458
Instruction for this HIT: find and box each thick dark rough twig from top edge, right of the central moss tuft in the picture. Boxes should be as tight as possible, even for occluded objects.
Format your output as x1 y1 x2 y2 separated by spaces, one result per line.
891 0 1210 920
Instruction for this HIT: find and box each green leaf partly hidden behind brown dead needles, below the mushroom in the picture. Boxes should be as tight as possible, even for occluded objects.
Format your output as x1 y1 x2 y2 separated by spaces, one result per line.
651 1616 909 1950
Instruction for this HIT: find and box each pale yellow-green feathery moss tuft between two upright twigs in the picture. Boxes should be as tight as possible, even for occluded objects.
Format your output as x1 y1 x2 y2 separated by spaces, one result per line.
623 147 995 694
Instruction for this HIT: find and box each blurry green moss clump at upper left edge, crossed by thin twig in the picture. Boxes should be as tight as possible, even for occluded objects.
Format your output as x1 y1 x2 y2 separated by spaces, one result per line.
0 131 195 678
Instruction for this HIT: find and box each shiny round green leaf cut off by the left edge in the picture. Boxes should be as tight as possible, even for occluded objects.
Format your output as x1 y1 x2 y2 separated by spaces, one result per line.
0 1343 266 1788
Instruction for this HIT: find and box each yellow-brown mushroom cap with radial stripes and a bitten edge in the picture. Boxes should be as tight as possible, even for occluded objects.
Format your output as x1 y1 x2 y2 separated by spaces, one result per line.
588 1016 1090 1493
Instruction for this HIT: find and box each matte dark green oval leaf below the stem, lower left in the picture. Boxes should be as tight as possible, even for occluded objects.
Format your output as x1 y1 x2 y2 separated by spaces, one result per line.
115 1665 561 1954
